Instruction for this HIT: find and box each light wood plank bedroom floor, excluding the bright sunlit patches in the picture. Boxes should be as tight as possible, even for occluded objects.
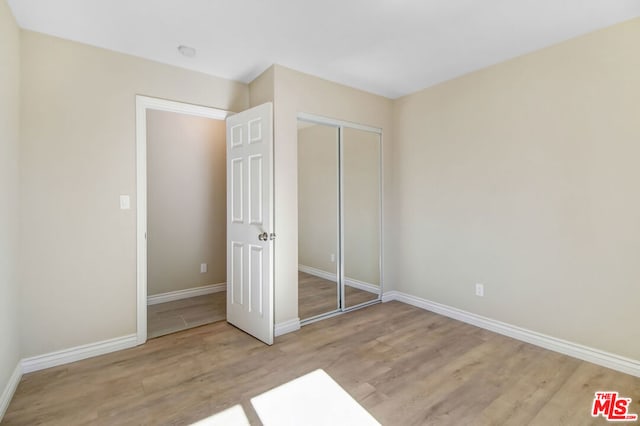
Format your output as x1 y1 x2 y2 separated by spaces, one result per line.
3 302 640 426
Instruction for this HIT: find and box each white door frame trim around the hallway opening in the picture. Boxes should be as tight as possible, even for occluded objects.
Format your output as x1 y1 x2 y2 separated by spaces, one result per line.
136 95 232 345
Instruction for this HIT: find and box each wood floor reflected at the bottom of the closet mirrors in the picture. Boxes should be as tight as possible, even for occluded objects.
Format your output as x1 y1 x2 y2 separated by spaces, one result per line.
298 271 378 319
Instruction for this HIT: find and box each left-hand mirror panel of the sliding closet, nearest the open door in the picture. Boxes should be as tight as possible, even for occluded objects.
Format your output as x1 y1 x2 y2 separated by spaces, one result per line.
298 120 340 320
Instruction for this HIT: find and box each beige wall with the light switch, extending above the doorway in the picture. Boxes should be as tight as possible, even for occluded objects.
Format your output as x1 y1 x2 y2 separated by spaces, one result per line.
20 31 249 356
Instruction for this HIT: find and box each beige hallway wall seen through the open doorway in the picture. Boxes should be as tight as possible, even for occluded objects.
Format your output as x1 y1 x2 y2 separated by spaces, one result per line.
147 110 227 295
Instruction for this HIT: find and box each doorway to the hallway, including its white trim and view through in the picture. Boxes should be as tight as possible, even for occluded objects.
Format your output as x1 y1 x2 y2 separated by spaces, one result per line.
136 96 229 344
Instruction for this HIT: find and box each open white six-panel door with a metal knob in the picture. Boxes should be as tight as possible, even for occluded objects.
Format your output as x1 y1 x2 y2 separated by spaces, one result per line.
227 103 275 345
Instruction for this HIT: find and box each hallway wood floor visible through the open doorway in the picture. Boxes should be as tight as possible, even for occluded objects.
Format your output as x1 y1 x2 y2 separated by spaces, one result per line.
147 291 227 339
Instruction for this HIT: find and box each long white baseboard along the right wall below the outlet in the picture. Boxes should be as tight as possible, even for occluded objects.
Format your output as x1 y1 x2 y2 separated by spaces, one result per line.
382 291 640 377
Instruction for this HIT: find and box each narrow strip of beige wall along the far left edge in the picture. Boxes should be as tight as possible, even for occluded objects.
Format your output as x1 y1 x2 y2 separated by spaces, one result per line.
0 0 20 406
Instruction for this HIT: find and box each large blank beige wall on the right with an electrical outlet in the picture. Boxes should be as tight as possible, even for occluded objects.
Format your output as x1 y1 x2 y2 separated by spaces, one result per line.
393 19 640 359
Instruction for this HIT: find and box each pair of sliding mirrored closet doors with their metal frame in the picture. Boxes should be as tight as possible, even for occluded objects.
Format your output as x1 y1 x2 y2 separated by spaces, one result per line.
298 114 382 324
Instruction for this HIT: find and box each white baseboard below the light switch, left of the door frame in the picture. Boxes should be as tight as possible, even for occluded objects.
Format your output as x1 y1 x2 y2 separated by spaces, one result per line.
22 334 138 374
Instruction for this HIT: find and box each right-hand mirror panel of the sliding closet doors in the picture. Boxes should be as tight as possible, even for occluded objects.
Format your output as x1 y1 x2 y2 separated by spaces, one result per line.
342 127 381 307
